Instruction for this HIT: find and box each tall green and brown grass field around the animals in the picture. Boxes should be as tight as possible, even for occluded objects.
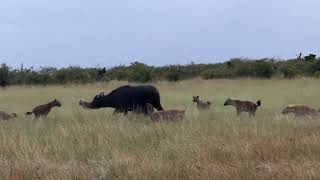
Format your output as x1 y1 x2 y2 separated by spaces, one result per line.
0 79 320 180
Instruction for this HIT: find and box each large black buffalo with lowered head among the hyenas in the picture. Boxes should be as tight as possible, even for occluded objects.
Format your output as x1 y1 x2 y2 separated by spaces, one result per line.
79 85 163 114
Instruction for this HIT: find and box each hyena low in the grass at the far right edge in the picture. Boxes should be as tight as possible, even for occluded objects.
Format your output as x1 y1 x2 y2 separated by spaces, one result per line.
281 105 320 116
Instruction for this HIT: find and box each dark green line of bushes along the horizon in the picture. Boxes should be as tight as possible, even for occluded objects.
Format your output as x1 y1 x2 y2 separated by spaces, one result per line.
0 58 320 87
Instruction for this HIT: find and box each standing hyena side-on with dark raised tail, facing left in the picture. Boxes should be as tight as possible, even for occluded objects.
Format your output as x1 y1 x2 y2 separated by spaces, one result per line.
224 98 261 116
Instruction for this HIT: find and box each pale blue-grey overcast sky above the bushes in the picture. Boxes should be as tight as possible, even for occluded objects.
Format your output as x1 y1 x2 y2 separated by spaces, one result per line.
0 0 320 67
